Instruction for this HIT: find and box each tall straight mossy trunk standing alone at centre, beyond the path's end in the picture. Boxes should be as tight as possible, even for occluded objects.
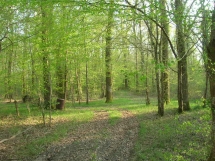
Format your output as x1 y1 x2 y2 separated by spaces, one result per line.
105 0 114 103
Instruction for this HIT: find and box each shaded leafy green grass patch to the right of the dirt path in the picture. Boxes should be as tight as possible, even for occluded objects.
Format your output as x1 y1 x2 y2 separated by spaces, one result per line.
135 108 210 161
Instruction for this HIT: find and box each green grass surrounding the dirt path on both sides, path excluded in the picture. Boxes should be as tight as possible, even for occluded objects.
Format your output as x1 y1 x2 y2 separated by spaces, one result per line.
0 92 211 161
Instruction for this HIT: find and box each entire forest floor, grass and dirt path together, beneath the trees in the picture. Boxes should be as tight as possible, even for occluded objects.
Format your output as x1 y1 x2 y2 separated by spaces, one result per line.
0 92 211 161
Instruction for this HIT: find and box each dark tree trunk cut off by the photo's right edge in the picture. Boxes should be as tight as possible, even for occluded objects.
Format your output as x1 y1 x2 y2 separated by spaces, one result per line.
207 2 215 161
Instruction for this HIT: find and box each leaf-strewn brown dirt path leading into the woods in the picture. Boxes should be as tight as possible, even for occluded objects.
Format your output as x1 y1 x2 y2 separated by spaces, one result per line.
35 111 139 161
